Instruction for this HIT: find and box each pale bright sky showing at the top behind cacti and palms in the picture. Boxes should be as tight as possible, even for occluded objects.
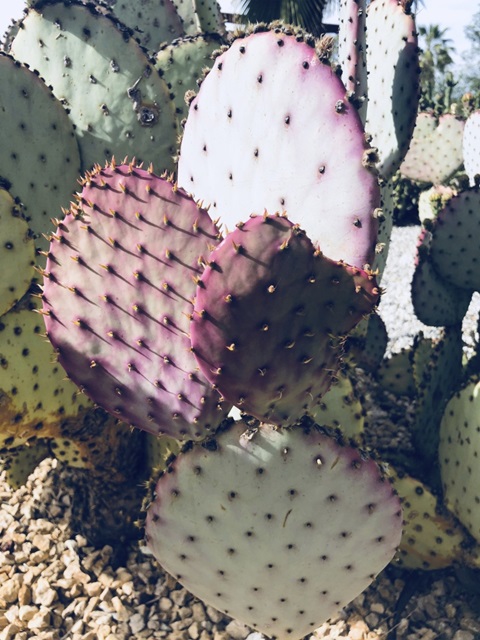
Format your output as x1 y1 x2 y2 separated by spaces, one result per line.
0 0 480 64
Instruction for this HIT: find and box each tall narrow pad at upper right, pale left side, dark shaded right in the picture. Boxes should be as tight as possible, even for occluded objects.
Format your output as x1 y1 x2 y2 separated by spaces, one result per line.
364 0 420 179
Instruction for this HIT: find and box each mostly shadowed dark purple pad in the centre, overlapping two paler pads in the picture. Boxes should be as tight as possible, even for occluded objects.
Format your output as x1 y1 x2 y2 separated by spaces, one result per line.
191 216 378 424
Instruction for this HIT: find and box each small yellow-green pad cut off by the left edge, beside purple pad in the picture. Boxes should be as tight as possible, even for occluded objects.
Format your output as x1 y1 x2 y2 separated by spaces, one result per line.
0 188 35 316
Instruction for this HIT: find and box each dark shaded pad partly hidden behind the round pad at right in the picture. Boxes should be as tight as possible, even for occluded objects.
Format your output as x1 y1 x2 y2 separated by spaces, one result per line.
411 230 472 327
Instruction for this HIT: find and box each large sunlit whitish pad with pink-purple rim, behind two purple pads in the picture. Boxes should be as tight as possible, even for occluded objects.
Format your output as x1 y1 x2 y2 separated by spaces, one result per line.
179 29 379 268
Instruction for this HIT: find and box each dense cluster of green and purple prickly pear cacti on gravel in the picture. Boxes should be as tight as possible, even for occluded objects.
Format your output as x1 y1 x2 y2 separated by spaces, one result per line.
0 0 480 638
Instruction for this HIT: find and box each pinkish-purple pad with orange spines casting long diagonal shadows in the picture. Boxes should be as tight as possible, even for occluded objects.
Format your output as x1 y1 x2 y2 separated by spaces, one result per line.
43 164 230 439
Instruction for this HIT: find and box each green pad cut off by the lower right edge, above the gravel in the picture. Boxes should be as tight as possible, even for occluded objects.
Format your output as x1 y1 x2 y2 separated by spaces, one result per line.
439 377 480 543
